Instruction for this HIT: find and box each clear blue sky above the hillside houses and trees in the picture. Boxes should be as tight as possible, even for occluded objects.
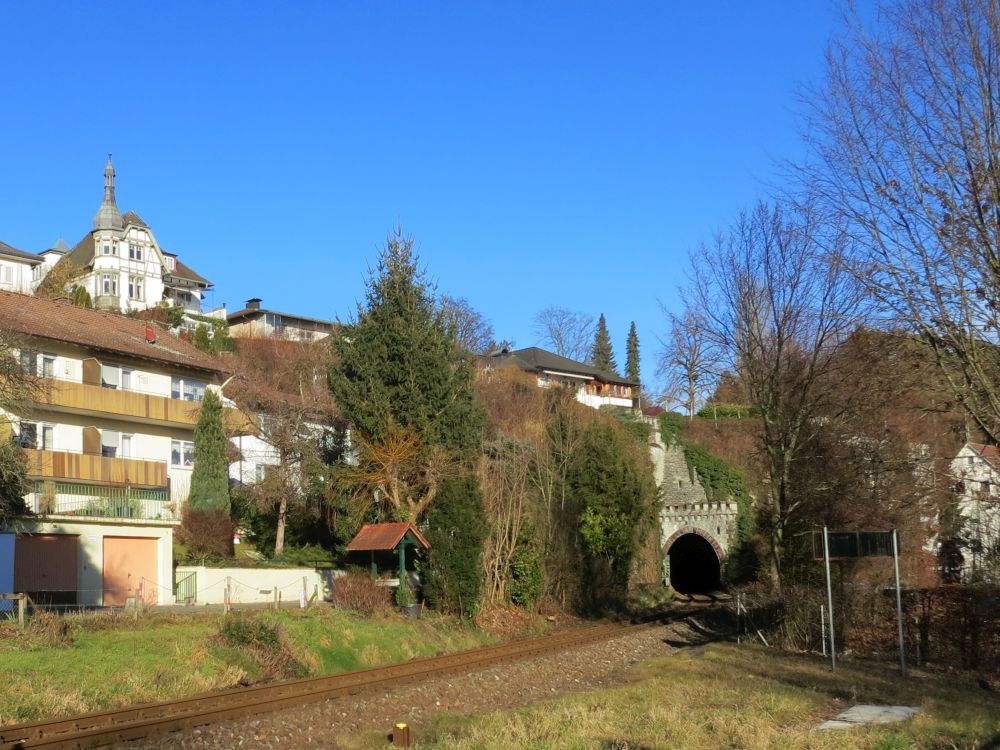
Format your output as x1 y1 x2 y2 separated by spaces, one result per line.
0 0 852 388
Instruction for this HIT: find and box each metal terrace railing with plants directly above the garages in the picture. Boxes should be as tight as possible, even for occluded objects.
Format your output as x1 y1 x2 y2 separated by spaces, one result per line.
31 480 180 522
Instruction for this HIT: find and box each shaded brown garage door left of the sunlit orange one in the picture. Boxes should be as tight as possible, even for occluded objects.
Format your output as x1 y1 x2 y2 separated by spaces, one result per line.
14 534 78 604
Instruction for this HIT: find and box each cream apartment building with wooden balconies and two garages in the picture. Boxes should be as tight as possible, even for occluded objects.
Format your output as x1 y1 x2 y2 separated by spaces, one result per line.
0 292 246 606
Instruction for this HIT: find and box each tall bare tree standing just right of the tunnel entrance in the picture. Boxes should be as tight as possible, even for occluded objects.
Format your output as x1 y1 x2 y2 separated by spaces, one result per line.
688 205 863 586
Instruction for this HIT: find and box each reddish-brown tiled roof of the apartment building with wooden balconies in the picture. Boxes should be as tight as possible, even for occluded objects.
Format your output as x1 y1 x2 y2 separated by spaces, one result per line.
0 292 226 373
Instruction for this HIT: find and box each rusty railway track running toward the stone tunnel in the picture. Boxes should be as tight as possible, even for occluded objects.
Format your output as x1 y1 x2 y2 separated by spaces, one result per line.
0 613 683 750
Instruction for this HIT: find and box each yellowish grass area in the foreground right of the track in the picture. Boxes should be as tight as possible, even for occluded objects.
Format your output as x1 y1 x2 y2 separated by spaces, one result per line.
349 644 1000 750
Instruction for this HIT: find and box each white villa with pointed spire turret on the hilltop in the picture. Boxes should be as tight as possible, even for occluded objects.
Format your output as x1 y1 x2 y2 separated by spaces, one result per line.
44 154 212 313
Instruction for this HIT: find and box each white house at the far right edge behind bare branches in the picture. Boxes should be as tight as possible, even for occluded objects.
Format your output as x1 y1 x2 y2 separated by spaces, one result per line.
951 443 1000 578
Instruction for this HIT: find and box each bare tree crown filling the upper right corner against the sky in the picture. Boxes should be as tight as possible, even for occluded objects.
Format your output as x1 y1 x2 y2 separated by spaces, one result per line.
800 0 1000 442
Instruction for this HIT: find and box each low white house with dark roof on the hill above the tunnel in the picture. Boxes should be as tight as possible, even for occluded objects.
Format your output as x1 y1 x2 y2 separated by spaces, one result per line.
480 346 639 409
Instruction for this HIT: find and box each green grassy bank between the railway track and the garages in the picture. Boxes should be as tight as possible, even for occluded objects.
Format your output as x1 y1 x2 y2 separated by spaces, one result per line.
0 607 489 724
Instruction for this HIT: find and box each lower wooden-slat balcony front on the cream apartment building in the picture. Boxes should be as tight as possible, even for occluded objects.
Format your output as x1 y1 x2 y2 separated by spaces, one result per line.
24 448 167 489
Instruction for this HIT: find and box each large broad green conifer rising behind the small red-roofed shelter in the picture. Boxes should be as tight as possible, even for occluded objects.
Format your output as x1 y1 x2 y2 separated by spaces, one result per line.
329 230 482 461
